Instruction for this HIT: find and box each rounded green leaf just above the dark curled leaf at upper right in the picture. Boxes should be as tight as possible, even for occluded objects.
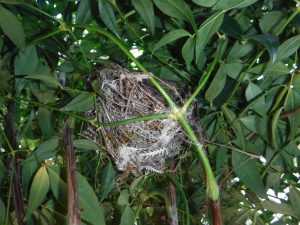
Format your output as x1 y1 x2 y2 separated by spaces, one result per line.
259 11 284 33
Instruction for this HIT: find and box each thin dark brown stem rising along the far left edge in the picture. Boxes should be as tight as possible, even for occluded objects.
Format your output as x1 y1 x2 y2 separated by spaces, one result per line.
5 101 24 225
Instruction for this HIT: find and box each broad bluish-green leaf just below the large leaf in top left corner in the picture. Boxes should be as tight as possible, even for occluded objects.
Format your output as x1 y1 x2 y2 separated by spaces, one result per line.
14 45 38 75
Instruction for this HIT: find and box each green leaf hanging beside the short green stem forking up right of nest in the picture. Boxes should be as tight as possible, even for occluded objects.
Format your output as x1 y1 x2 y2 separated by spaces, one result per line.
205 63 226 104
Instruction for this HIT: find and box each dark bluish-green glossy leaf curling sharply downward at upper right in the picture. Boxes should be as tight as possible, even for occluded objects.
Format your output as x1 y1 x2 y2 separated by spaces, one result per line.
243 34 279 64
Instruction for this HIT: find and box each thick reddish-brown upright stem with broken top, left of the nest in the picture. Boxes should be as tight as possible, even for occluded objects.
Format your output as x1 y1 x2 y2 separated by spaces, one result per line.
64 124 81 225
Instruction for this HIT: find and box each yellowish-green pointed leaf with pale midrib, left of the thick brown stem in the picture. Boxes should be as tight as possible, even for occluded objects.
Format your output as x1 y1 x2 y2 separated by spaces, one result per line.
24 166 50 220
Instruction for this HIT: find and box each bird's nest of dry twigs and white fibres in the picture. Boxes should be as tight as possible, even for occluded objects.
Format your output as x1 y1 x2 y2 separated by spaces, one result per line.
85 64 184 174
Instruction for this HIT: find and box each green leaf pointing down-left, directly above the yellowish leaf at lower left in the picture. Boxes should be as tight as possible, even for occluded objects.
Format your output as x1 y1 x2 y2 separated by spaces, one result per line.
24 137 59 163
